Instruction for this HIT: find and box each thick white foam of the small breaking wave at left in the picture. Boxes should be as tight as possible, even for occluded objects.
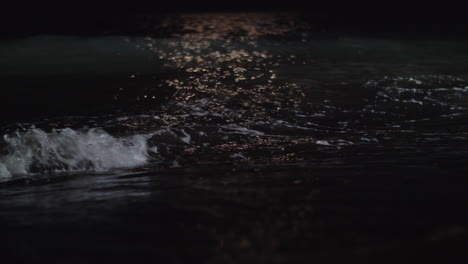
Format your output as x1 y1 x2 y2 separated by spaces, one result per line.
0 128 149 179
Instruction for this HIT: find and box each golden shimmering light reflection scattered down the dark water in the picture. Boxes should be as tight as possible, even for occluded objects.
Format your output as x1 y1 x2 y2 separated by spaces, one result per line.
125 13 348 165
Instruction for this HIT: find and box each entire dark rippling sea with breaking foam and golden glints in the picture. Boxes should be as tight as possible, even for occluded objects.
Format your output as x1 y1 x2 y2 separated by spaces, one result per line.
0 13 468 263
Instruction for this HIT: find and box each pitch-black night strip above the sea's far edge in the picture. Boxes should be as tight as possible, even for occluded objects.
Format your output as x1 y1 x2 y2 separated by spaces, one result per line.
1 0 468 36
